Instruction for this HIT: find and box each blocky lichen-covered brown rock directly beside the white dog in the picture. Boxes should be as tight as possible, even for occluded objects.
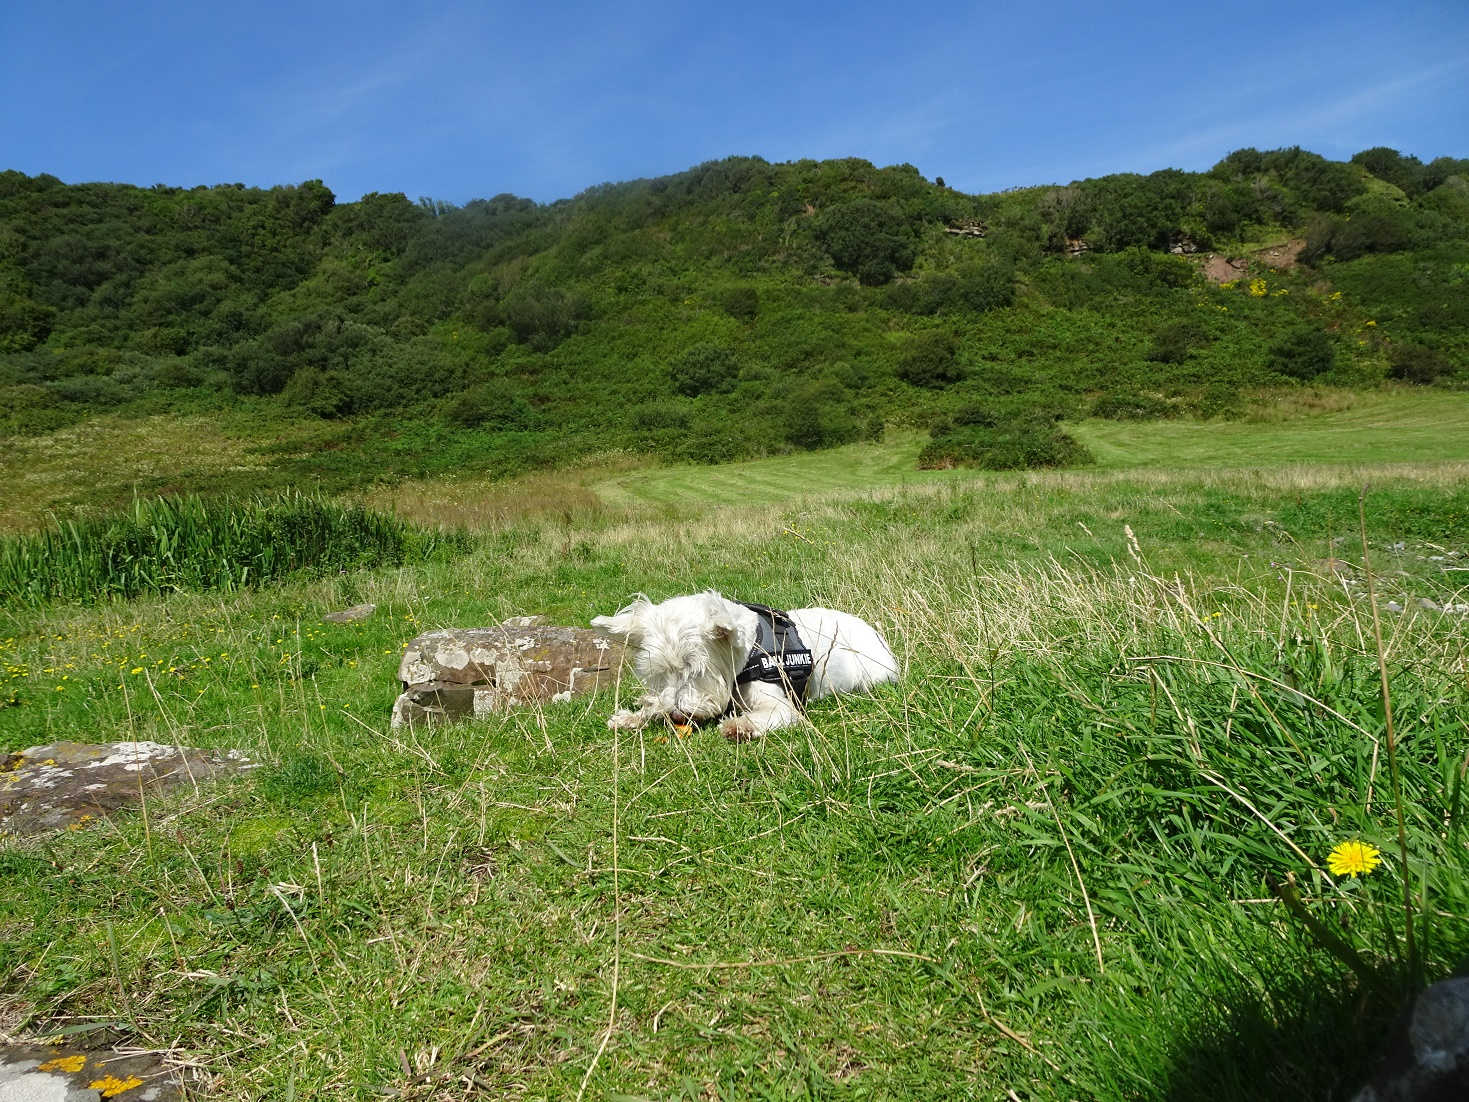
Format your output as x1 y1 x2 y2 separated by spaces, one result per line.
392 616 624 727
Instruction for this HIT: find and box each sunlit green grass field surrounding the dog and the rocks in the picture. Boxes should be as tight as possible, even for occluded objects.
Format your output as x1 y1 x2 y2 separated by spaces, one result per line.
0 395 1469 1102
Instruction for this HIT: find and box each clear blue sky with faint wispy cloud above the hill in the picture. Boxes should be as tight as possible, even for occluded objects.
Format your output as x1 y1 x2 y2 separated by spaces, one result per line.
0 0 1469 203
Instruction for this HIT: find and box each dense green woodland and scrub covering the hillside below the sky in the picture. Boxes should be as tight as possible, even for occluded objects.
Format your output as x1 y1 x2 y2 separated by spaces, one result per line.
0 148 1469 486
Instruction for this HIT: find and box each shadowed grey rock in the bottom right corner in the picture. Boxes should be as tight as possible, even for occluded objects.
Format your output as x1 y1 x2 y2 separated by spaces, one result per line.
1354 976 1469 1102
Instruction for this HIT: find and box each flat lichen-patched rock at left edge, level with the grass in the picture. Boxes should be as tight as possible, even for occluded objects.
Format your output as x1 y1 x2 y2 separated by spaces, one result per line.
0 742 254 835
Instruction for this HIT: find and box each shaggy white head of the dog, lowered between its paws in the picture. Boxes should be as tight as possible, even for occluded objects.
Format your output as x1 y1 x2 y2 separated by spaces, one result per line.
592 589 758 723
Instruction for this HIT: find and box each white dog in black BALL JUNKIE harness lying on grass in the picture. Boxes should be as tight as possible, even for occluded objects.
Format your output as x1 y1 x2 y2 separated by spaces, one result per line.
592 589 898 742
